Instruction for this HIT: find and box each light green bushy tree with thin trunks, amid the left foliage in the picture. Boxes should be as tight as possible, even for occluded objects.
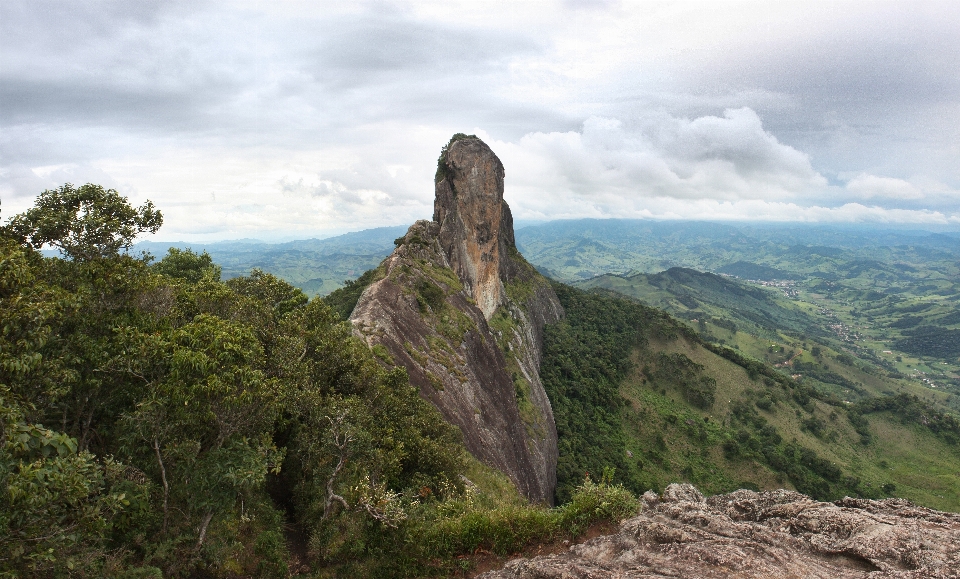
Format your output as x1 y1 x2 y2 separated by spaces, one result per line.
124 314 283 551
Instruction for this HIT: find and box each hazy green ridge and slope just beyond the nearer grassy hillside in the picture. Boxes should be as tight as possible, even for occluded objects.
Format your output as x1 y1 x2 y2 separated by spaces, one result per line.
574 268 960 408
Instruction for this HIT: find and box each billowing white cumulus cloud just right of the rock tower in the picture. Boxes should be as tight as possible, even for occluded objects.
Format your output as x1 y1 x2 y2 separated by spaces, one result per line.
490 108 827 214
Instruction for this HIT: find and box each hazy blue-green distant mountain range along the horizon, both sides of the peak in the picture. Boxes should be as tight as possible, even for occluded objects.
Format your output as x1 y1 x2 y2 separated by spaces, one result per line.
134 219 960 295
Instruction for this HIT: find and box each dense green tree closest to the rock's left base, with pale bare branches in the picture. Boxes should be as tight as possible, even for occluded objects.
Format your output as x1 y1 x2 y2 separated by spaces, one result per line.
276 299 464 561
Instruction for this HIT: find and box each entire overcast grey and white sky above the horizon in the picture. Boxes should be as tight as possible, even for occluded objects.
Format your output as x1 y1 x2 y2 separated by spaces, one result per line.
0 0 960 240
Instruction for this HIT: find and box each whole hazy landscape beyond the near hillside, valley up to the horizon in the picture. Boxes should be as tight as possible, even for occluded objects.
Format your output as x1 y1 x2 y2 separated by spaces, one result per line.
146 219 960 411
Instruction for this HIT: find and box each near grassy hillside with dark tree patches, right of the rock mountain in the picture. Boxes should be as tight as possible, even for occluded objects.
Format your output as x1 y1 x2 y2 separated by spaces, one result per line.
543 288 960 510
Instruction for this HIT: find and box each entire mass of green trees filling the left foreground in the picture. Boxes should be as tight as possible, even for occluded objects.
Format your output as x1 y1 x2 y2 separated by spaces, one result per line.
0 185 463 577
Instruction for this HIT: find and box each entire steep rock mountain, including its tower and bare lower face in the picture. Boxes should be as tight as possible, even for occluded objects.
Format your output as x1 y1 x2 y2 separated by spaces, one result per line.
350 138 563 503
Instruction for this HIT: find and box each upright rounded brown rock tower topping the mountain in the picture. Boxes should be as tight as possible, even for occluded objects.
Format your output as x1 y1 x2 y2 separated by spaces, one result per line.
433 133 516 319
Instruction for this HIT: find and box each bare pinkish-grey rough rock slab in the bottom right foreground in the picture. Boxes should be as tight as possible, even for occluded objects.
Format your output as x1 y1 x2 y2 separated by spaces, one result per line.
480 484 960 579
